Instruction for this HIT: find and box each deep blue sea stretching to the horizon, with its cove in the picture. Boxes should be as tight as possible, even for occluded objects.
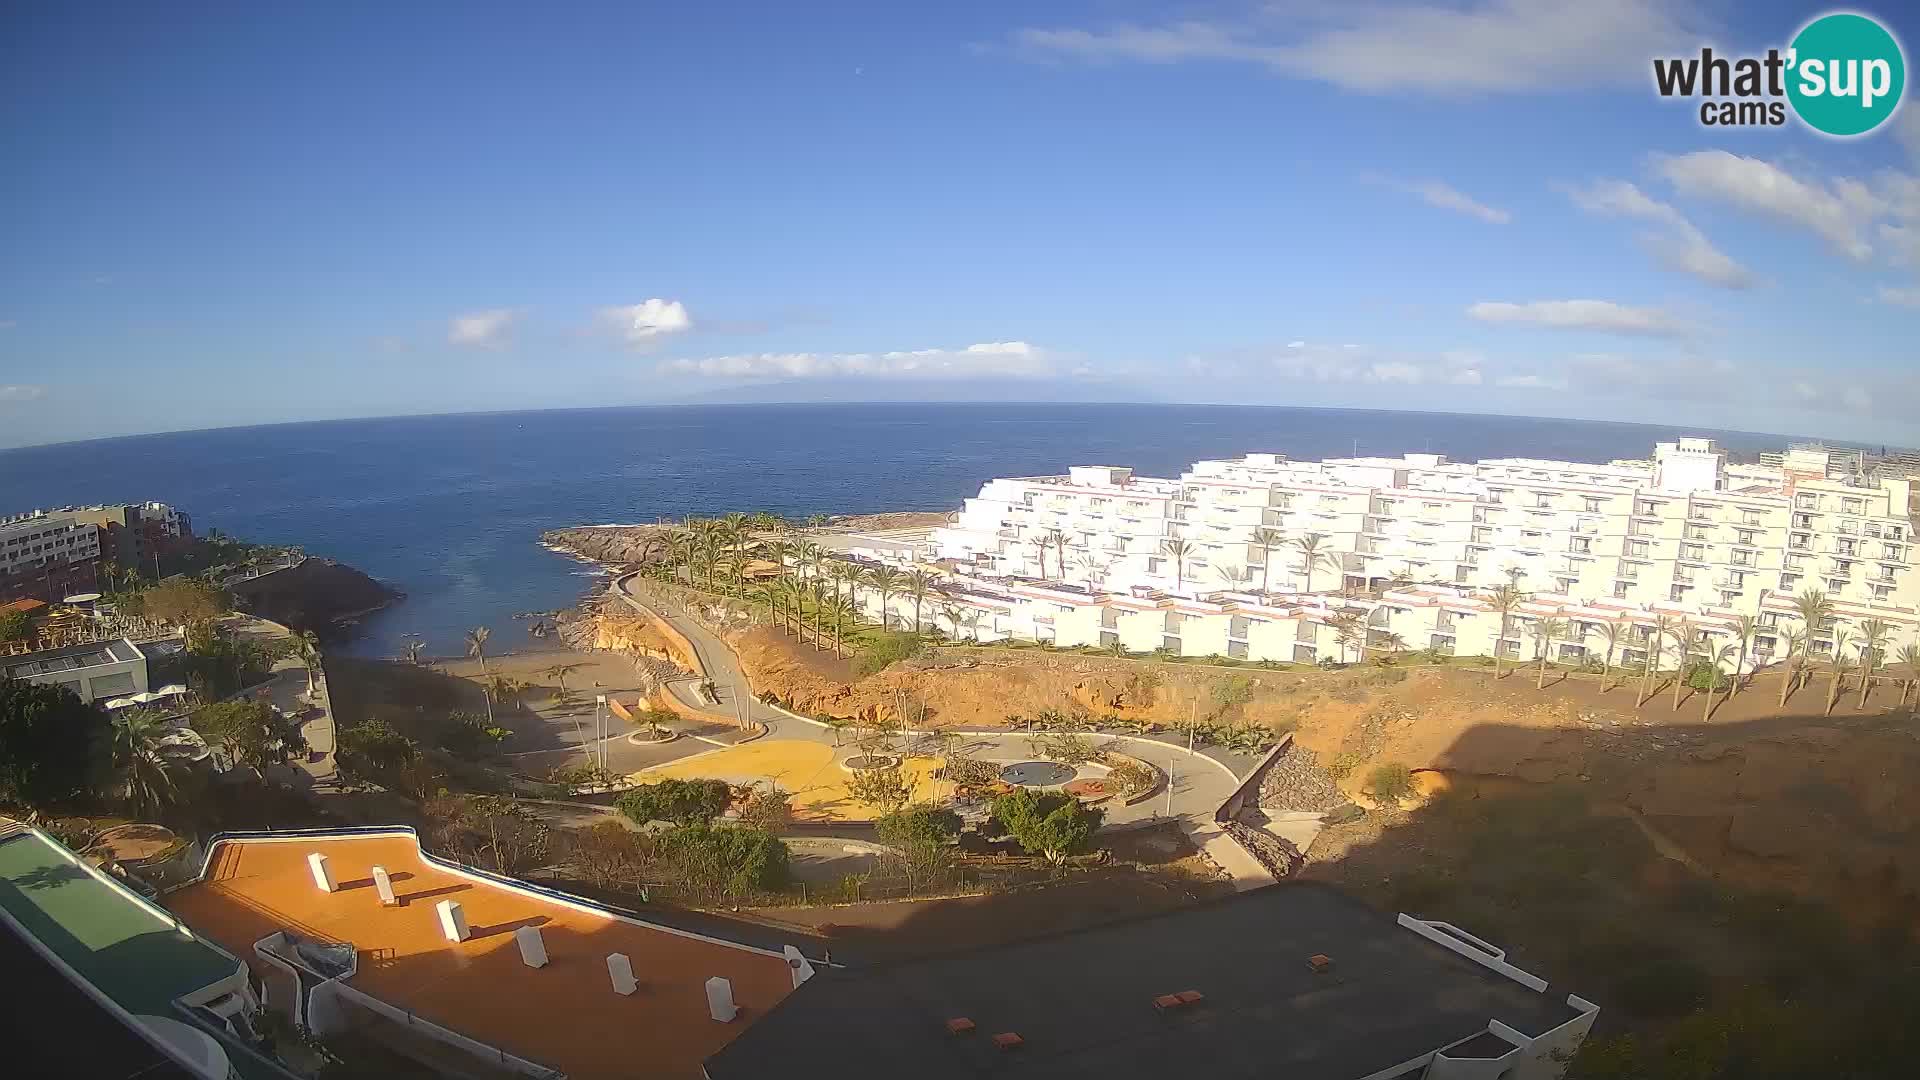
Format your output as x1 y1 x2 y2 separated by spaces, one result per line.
0 404 1784 655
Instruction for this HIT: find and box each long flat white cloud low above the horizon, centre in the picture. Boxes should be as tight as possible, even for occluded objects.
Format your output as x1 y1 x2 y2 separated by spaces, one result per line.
660 342 1059 379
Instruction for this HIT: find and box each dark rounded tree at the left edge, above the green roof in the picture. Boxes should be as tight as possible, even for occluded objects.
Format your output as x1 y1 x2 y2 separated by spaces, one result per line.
0 676 108 807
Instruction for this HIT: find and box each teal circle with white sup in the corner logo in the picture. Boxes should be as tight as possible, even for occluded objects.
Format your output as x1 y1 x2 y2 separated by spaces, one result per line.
1788 12 1907 136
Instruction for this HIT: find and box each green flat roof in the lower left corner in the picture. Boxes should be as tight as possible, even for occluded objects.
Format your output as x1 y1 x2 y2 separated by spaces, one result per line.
0 828 240 1019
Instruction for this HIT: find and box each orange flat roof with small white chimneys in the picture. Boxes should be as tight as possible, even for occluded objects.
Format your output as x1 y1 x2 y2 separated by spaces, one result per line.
167 830 793 1080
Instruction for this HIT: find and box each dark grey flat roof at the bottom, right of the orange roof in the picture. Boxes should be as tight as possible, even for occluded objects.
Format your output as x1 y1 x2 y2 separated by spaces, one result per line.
707 882 1580 1080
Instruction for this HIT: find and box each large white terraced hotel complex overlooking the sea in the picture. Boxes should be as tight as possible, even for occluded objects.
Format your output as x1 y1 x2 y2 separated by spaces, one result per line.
833 438 1920 667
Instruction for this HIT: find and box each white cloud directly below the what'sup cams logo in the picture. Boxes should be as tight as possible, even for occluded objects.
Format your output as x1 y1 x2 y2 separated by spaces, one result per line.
1655 150 1891 261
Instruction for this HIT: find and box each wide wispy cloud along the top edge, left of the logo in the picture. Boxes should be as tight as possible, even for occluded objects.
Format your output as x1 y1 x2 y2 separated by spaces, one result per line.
1014 0 1703 94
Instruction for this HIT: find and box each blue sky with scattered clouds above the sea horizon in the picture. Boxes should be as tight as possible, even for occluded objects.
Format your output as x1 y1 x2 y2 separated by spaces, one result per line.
0 0 1920 446
